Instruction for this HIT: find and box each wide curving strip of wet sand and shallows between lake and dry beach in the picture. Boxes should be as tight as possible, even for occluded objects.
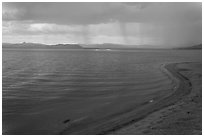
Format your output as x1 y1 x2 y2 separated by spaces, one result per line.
60 63 196 134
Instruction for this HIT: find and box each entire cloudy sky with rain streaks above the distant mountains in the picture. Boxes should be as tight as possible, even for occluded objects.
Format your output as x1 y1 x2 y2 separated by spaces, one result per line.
2 2 202 48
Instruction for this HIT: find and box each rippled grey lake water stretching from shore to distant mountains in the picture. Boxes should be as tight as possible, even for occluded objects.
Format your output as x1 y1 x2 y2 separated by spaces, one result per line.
2 49 202 134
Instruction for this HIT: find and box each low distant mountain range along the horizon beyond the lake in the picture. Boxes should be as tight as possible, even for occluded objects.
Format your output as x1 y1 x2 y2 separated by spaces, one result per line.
2 42 202 50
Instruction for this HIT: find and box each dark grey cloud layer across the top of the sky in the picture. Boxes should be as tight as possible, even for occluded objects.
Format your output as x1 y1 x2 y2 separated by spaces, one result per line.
3 3 202 24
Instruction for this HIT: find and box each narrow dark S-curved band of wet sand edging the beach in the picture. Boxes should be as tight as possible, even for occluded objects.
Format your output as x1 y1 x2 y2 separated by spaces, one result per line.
102 62 192 134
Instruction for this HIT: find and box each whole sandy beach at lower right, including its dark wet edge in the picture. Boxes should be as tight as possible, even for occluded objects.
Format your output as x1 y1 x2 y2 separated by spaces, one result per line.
109 62 202 135
